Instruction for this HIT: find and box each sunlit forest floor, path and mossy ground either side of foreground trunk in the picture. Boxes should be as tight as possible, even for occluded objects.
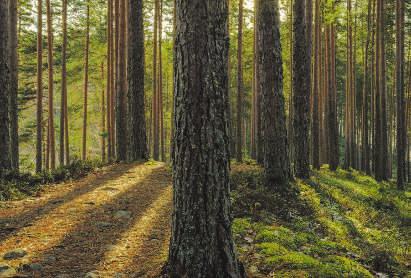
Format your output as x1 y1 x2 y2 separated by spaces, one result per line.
0 162 411 278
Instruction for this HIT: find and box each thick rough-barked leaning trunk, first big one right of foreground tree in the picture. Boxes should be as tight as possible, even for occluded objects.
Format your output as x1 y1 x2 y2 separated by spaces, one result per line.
257 0 290 187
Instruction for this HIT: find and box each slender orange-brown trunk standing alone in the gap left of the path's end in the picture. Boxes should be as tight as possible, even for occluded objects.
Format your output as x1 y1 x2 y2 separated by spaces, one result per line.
82 0 90 160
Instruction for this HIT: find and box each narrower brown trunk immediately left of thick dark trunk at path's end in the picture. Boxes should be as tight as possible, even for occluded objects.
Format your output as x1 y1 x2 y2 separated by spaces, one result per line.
116 0 127 161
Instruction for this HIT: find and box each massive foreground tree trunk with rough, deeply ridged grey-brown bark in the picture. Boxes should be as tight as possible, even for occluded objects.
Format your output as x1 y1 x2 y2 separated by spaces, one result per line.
164 0 245 278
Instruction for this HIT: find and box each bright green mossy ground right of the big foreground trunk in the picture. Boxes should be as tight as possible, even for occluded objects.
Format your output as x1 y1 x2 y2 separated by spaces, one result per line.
233 164 410 277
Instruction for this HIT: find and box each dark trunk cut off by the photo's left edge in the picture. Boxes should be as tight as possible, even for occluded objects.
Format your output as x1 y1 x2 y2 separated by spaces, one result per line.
0 0 11 174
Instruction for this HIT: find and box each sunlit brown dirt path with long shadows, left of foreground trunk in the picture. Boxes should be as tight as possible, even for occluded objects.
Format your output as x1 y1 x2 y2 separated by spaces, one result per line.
0 164 172 278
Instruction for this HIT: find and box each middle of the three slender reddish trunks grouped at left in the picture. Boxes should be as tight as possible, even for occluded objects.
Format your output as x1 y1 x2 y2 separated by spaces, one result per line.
46 0 56 170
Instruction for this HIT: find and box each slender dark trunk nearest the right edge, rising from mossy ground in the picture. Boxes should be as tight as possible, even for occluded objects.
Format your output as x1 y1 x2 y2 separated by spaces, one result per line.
396 0 407 189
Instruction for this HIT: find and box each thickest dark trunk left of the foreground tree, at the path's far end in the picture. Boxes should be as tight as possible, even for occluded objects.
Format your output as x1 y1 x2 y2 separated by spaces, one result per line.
127 0 148 161
